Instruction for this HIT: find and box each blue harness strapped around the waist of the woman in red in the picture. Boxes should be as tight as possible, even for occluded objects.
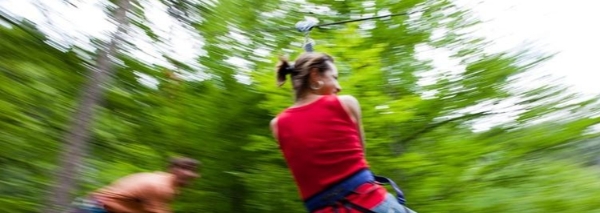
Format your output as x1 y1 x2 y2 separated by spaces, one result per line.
304 169 406 212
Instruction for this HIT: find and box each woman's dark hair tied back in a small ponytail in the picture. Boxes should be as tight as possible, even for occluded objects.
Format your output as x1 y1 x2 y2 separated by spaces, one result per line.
277 52 333 98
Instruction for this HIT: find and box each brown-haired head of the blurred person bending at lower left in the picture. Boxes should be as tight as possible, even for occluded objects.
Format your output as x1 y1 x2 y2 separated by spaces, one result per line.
168 157 200 186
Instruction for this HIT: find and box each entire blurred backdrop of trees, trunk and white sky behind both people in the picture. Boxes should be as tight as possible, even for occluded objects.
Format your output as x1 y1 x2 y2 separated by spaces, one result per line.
0 0 600 213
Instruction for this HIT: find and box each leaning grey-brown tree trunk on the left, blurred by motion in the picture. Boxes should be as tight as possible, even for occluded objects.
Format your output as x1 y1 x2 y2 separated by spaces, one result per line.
43 0 130 213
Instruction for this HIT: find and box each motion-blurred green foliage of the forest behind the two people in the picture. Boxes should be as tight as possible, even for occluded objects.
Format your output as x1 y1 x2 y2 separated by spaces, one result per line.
0 0 600 213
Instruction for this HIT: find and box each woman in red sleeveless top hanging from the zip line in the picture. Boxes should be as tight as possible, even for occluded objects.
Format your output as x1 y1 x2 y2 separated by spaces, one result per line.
271 52 412 213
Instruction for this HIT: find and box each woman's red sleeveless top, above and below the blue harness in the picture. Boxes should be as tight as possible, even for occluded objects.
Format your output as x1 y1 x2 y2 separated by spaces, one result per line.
277 95 386 211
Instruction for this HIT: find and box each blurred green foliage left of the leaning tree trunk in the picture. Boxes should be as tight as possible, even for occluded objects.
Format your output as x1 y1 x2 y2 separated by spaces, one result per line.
0 17 84 212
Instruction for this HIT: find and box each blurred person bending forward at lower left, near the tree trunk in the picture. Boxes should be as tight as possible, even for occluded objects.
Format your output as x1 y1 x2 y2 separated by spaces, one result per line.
73 157 200 213
